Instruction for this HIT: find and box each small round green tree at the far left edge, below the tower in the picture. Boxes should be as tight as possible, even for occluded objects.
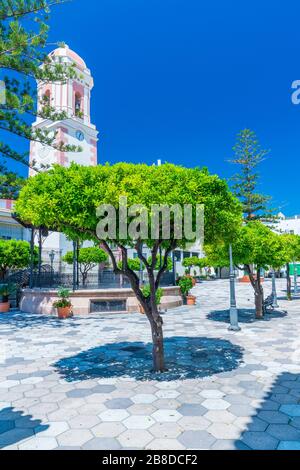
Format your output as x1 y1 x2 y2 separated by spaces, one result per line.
0 240 36 280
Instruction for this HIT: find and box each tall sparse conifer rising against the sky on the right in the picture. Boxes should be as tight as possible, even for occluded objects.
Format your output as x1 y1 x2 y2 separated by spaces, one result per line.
229 129 271 221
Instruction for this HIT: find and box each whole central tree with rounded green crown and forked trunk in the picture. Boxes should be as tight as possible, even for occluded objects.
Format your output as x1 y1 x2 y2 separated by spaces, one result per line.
16 163 241 371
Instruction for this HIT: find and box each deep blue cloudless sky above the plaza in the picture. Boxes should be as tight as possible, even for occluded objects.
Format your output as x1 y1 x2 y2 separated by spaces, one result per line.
3 0 300 215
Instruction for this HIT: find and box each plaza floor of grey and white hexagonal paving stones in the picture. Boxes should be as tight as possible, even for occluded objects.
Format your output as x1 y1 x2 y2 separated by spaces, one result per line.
0 280 300 450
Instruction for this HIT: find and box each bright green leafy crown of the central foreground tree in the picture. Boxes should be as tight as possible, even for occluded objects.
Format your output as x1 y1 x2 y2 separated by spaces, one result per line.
16 163 241 249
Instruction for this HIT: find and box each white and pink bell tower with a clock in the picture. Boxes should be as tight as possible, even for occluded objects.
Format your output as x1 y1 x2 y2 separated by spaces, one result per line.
30 45 98 175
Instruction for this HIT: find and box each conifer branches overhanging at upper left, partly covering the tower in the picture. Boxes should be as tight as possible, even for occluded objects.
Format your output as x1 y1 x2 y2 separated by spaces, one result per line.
0 0 81 197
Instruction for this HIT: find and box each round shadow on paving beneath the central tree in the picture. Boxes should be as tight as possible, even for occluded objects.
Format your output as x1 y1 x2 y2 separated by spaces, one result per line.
54 337 243 382
